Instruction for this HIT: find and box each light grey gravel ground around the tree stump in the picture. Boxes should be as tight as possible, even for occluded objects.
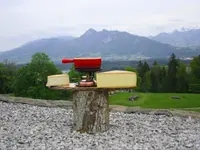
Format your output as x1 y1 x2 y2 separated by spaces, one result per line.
0 102 200 150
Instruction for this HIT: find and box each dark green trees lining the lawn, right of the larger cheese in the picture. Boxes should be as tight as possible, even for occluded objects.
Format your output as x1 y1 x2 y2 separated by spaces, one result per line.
130 54 200 93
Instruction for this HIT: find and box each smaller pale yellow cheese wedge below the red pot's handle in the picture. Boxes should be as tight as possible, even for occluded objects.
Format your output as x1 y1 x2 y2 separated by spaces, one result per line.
46 74 69 87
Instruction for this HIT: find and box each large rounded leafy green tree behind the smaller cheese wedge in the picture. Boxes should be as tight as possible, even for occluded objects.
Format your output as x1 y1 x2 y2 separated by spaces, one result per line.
14 53 71 99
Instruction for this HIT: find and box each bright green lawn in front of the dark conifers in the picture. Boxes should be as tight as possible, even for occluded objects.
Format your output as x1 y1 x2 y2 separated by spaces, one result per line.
109 92 200 108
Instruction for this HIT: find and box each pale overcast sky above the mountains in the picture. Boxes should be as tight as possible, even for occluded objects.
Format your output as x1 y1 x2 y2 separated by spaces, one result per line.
0 0 200 52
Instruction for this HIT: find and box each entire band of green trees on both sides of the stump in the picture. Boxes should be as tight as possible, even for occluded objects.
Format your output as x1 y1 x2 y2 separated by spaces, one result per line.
0 53 200 99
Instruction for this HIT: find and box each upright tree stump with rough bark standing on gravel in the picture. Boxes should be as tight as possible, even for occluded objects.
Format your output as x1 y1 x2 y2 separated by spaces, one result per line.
73 89 109 133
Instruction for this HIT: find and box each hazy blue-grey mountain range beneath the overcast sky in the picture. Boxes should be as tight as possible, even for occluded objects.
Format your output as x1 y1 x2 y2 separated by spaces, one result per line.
0 29 200 64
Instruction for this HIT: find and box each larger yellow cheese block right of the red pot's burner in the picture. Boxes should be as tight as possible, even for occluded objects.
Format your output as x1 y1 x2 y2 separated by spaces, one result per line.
96 70 137 88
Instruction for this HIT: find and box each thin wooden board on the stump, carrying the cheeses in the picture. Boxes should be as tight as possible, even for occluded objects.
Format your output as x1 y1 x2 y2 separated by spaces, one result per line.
50 83 135 91
